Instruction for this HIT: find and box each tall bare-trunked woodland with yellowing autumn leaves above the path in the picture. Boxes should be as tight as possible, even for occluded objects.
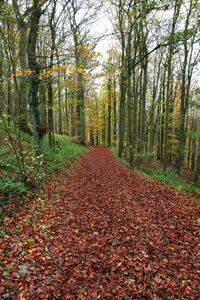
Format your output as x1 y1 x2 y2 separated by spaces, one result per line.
0 0 200 182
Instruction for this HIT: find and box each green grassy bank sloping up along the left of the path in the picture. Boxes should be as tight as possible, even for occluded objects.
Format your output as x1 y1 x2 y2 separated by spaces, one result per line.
0 122 86 215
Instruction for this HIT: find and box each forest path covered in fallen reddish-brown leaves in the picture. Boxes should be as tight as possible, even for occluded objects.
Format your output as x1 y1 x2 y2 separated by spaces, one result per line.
0 147 199 300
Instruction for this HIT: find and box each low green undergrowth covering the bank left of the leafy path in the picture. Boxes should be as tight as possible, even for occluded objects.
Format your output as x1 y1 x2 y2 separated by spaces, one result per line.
0 116 86 215
